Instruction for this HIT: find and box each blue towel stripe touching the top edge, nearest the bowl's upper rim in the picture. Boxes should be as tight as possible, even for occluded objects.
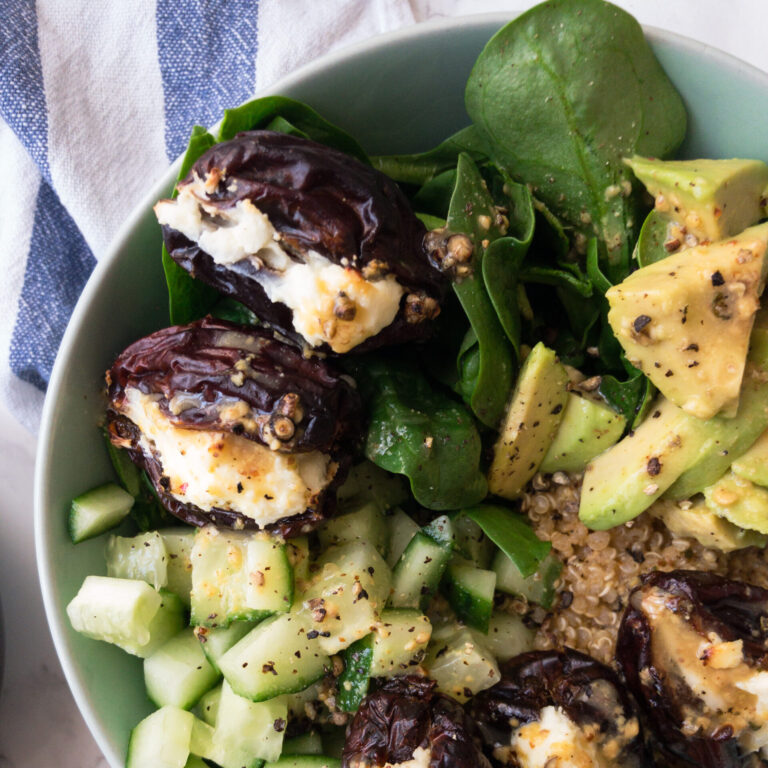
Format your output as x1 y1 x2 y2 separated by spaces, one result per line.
156 0 260 160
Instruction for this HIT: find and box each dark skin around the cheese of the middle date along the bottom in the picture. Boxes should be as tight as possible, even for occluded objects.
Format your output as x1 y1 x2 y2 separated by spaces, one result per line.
467 649 653 768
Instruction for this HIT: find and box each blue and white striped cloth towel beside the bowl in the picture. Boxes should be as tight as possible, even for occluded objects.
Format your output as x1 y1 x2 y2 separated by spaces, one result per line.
0 0 415 431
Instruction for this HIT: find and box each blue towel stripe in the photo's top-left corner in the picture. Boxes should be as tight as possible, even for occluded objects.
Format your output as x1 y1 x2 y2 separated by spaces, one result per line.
0 0 51 181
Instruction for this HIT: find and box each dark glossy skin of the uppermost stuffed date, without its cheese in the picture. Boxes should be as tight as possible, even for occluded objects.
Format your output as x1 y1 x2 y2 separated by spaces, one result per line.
163 131 445 352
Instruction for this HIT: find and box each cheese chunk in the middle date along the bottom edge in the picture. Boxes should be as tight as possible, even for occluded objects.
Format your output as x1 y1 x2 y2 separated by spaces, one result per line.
511 706 609 768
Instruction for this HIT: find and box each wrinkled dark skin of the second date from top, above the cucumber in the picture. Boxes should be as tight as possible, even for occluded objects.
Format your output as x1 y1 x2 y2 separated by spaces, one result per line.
107 318 364 536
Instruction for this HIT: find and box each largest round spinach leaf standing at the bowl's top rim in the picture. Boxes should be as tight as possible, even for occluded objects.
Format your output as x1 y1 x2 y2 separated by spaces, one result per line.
465 0 686 282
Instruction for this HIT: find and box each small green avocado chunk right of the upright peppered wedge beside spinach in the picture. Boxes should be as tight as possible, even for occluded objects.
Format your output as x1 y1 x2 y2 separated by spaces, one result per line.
539 391 627 472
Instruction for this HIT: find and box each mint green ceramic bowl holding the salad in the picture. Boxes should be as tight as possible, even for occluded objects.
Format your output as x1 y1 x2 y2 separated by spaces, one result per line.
35 14 768 768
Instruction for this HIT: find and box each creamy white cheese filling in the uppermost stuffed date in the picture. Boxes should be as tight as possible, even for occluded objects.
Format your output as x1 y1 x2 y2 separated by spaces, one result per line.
155 176 405 354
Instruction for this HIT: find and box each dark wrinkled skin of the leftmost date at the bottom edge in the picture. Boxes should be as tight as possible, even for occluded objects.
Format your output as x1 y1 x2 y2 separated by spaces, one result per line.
341 675 490 768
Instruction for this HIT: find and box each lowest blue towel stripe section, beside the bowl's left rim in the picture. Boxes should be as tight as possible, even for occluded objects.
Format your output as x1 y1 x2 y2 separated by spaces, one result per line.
9 181 96 390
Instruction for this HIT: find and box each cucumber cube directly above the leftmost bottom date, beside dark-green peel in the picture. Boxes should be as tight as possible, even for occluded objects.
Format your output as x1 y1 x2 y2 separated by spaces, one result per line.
370 608 432 677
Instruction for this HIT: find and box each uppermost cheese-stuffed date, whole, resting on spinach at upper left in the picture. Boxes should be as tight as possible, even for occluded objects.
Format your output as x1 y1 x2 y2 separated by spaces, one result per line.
155 131 442 354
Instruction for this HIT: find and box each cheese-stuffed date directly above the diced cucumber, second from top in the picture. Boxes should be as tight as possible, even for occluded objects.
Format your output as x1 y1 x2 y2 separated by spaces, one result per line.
107 318 362 536
